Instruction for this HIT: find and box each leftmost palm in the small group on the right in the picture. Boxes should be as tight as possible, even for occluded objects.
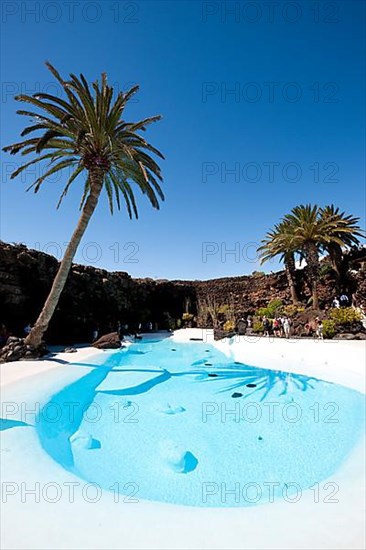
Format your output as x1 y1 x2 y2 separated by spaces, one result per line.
258 222 299 305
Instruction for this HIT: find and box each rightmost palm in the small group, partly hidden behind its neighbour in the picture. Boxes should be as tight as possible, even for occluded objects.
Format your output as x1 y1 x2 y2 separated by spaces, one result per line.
319 204 365 283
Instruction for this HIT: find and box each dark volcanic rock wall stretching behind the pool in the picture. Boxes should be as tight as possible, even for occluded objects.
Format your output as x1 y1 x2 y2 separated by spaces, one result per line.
0 242 366 344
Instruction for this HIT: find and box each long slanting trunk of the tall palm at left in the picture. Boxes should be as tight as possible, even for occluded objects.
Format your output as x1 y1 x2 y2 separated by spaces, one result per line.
25 169 104 348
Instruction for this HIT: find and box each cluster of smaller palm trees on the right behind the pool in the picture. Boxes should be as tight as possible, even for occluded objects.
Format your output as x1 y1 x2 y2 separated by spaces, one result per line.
258 204 365 309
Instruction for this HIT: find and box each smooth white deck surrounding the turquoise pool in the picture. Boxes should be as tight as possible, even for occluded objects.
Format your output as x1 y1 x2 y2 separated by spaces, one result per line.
0 329 366 550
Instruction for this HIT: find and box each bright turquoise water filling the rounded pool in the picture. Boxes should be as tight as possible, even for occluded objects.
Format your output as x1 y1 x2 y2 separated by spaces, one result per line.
36 338 364 507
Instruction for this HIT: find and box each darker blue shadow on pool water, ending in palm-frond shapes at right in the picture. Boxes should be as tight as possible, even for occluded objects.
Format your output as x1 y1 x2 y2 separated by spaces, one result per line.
33 363 324 471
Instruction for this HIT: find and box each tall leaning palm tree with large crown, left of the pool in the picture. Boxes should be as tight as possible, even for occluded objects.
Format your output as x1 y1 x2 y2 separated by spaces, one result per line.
4 63 164 348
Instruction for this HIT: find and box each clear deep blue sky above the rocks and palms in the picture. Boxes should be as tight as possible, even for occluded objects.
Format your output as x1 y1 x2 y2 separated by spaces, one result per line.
0 0 366 279
